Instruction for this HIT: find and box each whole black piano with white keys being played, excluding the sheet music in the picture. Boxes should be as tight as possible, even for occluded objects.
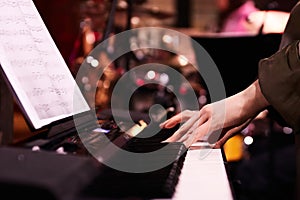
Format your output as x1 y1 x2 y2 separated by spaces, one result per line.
0 115 234 200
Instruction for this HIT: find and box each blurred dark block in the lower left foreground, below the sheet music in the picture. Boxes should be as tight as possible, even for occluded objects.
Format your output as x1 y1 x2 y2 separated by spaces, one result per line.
0 146 99 200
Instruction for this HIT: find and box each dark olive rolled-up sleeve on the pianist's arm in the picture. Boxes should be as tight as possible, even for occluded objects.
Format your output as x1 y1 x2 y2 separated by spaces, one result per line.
258 40 300 133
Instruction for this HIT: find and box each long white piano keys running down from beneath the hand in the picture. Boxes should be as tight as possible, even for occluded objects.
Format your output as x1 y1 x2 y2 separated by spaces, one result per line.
172 146 233 200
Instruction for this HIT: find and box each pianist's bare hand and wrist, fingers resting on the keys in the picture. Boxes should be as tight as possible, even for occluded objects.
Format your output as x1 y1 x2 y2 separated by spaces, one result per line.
160 81 269 148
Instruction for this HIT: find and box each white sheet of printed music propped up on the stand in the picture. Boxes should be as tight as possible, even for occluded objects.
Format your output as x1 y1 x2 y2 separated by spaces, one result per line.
0 0 89 129
